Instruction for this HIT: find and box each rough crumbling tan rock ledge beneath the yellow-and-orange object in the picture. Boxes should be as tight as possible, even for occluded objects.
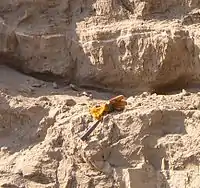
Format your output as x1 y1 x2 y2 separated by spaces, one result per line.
0 66 200 188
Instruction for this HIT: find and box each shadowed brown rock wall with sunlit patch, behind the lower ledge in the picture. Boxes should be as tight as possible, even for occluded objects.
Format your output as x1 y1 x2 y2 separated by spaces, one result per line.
0 0 200 93
